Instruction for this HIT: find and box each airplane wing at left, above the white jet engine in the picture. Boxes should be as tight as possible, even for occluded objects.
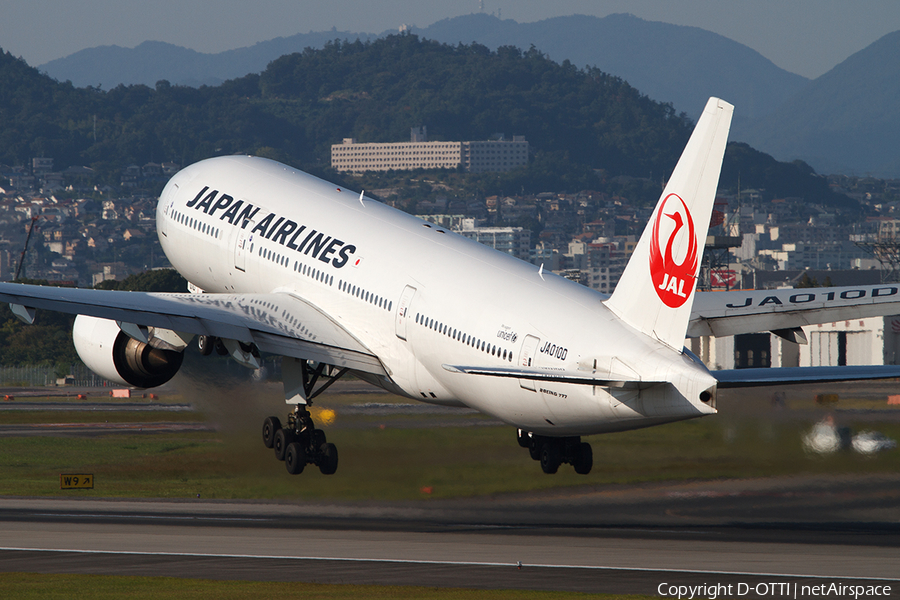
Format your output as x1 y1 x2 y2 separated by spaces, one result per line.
0 283 385 375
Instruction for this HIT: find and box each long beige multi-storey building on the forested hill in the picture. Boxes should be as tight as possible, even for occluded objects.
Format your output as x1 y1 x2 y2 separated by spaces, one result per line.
331 127 528 173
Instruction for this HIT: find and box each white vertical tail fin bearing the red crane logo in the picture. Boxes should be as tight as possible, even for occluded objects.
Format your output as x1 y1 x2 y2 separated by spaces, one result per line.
606 98 734 350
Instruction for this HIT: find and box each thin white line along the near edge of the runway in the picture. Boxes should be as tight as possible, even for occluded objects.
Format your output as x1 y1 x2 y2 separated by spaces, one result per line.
0 546 900 581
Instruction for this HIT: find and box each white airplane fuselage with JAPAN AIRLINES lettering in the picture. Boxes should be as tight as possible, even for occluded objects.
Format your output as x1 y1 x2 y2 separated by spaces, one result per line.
157 156 715 436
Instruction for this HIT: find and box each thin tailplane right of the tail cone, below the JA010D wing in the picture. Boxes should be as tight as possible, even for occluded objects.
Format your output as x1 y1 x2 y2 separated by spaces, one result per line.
710 365 900 389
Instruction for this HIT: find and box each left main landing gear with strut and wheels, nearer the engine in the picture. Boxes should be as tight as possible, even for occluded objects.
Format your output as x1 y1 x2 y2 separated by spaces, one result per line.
262 362 348 475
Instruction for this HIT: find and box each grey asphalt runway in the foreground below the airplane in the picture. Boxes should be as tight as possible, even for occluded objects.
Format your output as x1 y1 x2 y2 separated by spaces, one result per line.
0 476 900 598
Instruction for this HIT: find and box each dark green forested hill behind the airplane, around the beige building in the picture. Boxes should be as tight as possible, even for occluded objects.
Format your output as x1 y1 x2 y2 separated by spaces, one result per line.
0 35 852 201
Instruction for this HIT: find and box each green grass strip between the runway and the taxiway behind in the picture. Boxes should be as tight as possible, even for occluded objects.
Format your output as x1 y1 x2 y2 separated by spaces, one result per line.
0 382 900 500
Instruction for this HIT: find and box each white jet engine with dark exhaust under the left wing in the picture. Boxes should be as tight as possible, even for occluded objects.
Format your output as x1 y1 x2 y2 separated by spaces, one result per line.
72 315 184 388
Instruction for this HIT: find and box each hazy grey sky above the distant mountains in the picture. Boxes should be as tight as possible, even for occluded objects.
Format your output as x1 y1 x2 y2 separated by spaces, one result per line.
0 0 900 77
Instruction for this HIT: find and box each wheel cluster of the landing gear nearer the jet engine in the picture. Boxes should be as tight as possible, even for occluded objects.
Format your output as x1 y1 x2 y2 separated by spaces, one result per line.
263 404 337 475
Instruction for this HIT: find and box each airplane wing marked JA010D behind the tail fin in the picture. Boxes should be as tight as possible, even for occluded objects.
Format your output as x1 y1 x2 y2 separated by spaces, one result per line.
687 284 900 337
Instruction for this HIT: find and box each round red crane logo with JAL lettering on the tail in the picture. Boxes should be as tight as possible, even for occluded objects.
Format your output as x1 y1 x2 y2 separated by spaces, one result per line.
650 194 697 308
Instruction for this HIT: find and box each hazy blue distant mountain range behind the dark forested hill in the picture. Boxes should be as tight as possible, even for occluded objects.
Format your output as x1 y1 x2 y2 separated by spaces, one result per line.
40 14 900 177
